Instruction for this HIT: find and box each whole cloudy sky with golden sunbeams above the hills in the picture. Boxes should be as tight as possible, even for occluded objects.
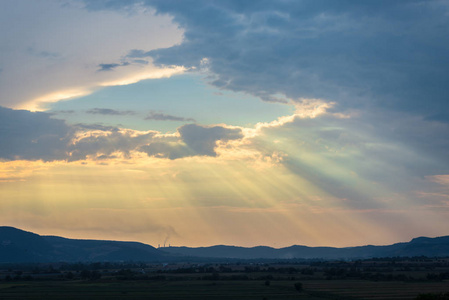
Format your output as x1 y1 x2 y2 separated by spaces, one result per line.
0 0 449 248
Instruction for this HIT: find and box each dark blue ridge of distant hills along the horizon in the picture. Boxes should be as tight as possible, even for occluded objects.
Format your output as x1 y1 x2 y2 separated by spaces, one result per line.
0 226 449 263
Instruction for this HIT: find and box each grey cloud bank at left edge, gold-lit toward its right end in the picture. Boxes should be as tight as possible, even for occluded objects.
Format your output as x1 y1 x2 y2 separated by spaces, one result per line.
0 107 157 161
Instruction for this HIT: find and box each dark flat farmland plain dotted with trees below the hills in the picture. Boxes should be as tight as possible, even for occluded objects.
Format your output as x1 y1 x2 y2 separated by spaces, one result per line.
0 257 449 300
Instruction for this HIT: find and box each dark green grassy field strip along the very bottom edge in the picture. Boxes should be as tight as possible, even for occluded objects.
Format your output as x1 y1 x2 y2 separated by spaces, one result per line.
0 280 449 300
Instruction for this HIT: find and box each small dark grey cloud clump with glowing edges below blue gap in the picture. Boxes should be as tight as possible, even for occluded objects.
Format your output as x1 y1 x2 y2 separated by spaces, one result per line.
140 124 243 159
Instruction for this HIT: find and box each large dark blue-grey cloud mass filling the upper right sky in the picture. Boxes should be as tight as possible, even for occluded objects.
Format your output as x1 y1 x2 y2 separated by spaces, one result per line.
111 0 449 120
